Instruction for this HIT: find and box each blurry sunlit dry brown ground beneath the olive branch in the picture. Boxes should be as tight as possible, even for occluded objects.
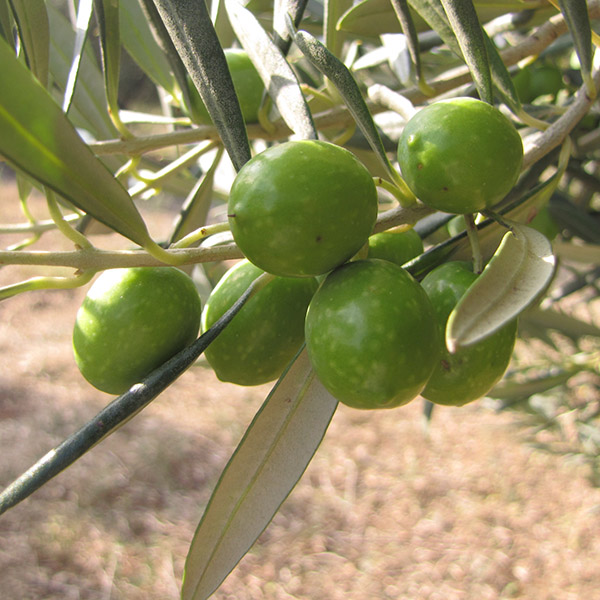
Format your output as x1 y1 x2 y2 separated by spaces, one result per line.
0 185 600 600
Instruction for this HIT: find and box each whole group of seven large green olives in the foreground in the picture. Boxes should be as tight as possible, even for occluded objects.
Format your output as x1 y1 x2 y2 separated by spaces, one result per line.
73 98 522 408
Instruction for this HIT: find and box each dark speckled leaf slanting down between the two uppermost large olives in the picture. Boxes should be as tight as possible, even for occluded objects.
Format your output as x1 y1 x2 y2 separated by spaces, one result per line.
290 25 398 181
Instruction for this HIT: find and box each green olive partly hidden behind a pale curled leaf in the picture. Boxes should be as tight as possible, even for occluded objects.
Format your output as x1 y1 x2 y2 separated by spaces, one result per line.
421 261 517 406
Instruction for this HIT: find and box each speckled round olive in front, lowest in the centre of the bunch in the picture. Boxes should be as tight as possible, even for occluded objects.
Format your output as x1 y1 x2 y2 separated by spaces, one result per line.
305 259 439 409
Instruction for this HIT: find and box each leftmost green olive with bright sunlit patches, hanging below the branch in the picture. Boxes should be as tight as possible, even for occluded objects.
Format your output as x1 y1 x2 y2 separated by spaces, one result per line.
73 267 201 394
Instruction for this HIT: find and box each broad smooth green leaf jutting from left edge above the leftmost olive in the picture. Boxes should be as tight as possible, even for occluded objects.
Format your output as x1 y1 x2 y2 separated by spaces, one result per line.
0 39 153 246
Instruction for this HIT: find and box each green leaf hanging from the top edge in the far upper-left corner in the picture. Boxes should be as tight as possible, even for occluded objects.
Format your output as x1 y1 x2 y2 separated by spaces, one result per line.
9 0 50 87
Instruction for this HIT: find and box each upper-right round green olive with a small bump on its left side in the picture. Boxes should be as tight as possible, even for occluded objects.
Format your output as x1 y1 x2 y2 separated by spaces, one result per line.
398 98 523 214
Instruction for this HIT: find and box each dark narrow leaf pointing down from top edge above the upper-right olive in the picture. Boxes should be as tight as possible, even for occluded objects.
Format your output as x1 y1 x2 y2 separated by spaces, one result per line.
441 0 494 104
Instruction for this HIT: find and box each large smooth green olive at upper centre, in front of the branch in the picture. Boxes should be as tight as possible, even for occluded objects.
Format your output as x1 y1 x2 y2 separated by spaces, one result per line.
228 140 377 277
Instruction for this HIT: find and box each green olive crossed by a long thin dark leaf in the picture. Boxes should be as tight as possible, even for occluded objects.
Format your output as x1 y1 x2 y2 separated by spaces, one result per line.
202 260 317 385
